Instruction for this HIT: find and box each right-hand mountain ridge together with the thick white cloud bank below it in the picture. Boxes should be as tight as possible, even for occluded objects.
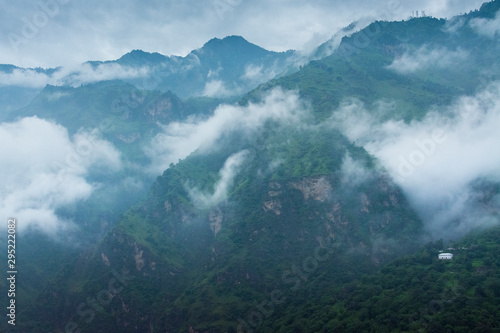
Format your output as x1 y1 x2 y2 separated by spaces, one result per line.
244 1 500 237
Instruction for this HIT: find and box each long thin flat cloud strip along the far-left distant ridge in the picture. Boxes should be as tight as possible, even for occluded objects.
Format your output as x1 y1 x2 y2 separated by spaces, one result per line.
0 64 149 88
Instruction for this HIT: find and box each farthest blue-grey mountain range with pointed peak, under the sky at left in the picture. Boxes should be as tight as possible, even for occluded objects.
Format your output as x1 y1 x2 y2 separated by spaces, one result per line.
0 36 299 112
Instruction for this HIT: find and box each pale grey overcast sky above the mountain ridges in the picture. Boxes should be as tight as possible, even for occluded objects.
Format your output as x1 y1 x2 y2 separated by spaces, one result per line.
0 0 484 67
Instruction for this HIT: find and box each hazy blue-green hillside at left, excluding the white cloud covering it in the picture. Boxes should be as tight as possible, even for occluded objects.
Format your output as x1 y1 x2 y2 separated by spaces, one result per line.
2 81 229 312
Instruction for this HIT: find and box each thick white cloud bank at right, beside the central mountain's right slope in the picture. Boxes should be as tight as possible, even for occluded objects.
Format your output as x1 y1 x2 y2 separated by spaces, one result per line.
332 83 500 237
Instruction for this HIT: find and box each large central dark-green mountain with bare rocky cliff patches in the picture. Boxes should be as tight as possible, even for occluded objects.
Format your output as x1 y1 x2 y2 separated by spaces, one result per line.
26 107 421 332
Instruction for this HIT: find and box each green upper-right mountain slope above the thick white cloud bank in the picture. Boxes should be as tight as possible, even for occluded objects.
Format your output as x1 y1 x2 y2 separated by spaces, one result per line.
248 1 500 121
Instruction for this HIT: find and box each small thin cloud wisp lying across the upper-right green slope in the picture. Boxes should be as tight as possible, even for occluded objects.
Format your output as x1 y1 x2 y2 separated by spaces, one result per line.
387 46 468 74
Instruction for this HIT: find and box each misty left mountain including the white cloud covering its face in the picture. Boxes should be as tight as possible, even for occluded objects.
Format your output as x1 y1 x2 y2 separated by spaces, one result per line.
0 81 232 312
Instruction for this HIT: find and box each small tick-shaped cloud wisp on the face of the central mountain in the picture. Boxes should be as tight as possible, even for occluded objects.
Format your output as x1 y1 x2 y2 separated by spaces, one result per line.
186 150 250 209
